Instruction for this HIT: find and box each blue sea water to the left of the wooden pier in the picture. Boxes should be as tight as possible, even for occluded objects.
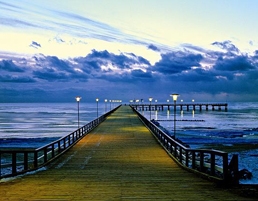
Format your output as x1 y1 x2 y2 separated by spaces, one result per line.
0 102 110 148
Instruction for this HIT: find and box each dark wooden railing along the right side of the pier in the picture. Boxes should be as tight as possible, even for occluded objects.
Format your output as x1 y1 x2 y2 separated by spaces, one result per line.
134 106 239 185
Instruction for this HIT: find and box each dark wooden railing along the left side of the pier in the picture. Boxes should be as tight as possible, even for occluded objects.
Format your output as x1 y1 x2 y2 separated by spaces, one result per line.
0 106 120 178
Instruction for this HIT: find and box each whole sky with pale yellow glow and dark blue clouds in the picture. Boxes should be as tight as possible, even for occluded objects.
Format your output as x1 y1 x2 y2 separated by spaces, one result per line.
0 0 258 103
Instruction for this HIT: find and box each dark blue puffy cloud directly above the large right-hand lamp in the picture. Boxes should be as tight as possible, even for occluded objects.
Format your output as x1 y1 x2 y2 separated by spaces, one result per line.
152 51 203 75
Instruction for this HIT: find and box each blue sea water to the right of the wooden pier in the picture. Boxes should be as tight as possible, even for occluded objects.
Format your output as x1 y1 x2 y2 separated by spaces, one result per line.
141 103 258 184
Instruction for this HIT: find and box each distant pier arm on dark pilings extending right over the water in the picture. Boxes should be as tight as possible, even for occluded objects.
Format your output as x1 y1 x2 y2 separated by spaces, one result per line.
131 103 228 111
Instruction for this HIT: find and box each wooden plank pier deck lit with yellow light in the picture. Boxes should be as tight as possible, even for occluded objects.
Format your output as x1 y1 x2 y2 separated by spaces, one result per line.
0 106 256 201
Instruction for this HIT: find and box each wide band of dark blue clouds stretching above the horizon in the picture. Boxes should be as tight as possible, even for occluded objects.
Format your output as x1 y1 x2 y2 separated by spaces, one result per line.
0 40 258 101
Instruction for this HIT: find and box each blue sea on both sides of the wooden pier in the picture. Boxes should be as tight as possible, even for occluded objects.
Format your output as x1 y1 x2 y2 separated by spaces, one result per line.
0 102 258 184
